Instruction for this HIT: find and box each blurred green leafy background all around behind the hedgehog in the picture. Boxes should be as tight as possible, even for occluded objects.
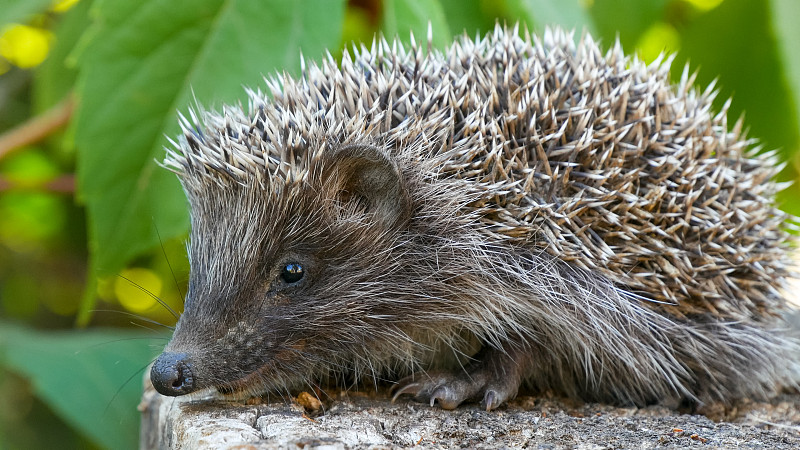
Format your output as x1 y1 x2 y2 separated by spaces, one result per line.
0 0 800 448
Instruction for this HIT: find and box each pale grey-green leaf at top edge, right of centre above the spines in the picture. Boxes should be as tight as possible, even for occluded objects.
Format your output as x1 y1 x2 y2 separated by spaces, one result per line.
506 0 595 34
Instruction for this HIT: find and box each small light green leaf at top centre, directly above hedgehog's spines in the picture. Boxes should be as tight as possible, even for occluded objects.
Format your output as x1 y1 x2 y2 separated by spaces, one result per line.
381 0 451 48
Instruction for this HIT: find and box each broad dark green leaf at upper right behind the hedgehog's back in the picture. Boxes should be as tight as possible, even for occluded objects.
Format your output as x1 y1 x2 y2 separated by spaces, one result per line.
673 0 800 160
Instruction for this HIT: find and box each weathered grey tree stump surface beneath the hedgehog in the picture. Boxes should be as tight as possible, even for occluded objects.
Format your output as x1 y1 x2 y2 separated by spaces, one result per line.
139 374 800 450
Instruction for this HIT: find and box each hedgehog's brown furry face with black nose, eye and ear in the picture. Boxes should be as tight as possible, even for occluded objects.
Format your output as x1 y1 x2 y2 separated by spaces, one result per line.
151 146 410 396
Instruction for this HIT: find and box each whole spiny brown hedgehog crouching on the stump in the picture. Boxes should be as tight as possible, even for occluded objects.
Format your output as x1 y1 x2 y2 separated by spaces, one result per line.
151 25 800 410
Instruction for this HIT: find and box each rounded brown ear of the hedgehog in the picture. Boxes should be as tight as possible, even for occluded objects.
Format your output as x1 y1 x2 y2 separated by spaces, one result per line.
329 145 411 226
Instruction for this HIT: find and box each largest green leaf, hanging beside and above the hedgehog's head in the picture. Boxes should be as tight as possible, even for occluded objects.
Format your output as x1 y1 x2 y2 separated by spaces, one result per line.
75 0 344 323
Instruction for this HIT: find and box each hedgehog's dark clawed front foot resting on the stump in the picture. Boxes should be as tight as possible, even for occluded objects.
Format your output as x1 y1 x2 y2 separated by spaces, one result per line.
392 346 532 411
